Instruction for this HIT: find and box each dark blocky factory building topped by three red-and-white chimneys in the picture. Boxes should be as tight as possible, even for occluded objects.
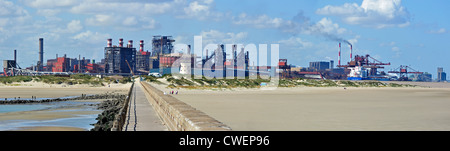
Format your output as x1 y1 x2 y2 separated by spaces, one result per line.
105 38 136 73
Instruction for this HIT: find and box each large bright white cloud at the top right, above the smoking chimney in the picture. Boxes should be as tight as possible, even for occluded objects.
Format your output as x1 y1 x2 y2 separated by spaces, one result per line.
316 0 410 28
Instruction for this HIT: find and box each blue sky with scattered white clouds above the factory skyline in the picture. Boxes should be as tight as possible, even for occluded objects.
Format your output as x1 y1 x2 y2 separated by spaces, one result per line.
0 0 450 78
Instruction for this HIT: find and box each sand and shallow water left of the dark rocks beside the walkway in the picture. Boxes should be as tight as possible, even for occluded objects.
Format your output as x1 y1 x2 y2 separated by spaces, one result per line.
0 82 131 131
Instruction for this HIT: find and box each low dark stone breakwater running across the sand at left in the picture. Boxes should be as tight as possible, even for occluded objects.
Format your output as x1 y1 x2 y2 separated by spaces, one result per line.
0 93 125 105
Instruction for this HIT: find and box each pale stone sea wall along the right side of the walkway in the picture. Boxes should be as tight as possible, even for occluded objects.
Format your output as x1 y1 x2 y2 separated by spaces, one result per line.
141 81 231 131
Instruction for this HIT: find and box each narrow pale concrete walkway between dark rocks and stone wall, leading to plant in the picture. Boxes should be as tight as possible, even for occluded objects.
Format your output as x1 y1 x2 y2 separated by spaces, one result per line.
123 81 168 131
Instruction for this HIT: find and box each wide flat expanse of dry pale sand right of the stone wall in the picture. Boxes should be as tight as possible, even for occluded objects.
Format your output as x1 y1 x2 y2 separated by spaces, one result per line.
153 84 450 131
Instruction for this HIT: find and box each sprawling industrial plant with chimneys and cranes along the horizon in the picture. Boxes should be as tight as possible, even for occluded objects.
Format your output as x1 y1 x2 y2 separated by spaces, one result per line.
1 35 446 82
